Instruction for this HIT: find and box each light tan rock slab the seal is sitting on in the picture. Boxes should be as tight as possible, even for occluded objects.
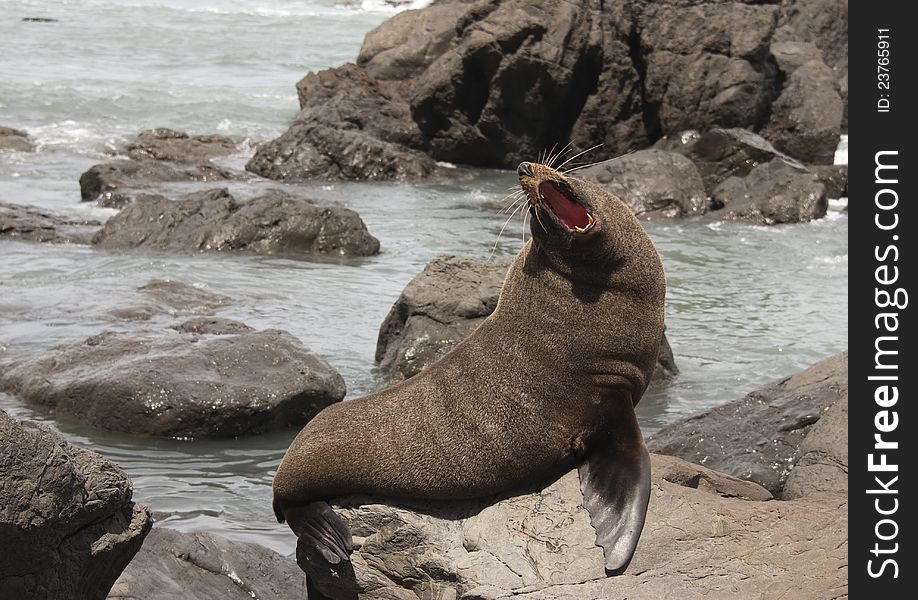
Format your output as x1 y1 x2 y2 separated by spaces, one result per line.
330 455 848 600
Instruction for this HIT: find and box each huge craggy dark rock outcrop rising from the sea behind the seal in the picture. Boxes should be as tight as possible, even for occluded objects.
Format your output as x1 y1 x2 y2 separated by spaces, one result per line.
249 0 847 179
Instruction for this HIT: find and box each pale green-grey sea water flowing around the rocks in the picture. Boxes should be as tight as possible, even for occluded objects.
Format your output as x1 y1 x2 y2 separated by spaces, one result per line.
0 0 848 553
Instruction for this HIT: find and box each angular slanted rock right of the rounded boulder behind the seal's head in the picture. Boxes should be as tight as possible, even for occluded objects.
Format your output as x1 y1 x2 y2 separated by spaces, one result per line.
659 128 794 194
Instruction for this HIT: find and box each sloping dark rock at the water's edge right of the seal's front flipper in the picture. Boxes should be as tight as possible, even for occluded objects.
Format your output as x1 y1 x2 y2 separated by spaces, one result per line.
647 352 848 496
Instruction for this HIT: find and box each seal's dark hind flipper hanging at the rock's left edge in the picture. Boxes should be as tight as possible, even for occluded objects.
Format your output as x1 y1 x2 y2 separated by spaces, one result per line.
283 502 357 600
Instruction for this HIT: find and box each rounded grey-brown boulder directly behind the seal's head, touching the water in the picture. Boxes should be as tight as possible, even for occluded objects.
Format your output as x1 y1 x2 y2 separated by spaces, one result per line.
574 148 708 218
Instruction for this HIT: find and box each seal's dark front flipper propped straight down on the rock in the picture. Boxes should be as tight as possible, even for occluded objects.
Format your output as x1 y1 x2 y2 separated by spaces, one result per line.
580 406 650 572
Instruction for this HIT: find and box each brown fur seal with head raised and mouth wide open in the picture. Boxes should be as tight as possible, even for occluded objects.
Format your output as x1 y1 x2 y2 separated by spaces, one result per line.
274 157 666 592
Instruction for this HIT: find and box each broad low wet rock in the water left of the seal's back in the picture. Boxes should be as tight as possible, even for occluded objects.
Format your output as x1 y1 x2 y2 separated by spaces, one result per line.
0 322 345 438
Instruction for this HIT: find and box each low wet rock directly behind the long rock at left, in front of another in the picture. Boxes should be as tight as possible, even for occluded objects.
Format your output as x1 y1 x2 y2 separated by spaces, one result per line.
80 160 240 208
